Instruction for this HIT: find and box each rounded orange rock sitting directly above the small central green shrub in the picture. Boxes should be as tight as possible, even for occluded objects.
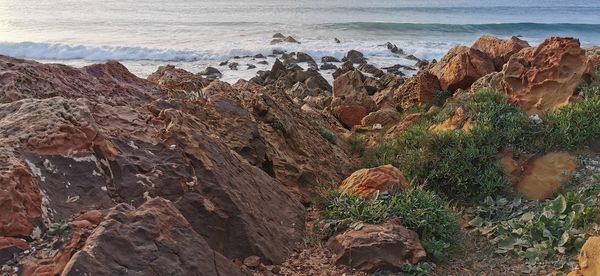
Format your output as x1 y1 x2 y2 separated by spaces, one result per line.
339 165 410 198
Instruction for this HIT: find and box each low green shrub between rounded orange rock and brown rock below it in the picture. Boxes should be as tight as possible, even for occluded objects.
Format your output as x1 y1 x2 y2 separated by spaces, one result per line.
323 187 459 261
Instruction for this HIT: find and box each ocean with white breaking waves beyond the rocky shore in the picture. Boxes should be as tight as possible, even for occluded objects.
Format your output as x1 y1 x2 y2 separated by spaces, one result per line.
0 0 600 82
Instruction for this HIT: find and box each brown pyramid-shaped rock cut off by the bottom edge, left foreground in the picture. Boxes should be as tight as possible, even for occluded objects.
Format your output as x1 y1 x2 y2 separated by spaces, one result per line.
63 198 241 275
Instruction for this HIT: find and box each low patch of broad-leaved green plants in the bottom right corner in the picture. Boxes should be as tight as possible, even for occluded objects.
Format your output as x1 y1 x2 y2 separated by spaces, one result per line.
469 184 600 268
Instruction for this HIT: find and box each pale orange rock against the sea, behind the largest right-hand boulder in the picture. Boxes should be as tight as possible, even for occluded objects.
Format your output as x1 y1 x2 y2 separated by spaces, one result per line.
471 35 531 71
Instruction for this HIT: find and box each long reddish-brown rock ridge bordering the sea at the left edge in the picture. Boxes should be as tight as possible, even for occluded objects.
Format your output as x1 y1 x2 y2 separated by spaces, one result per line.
0 55 160 105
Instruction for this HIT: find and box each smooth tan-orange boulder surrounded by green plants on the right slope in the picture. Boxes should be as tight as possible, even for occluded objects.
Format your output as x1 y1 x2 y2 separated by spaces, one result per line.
500 152 577 200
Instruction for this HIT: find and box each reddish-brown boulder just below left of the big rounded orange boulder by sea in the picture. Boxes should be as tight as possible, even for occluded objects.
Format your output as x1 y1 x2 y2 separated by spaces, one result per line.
393 71 442 109
